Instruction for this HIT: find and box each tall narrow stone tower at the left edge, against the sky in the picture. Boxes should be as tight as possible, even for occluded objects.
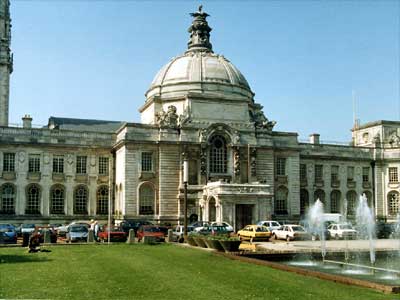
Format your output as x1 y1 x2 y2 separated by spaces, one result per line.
0 0 13 126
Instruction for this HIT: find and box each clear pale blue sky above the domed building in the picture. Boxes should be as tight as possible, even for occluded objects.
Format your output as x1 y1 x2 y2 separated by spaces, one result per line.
10 0 400 141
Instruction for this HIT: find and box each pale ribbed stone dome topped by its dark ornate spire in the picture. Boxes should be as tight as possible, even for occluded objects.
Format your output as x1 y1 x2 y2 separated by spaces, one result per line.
146 7 254 99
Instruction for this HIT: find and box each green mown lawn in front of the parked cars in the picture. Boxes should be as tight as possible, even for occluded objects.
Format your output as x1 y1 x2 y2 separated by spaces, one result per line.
0 244 399 300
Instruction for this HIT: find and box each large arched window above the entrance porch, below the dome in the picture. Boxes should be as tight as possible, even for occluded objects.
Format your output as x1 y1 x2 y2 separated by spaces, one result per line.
210 135 228 174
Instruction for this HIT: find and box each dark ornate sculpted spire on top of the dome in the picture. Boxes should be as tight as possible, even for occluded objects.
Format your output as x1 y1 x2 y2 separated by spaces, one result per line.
188 5 212 52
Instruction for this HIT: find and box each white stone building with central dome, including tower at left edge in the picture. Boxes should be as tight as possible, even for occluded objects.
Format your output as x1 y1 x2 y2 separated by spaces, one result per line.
0 0 400 229
